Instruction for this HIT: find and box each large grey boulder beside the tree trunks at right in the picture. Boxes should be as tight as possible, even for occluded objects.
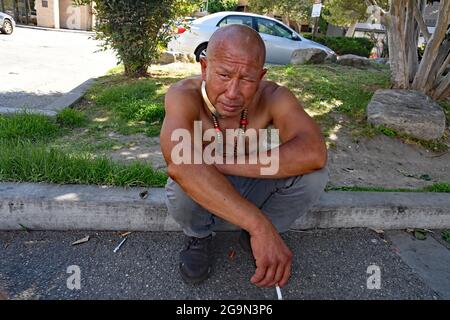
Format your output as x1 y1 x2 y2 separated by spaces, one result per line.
366 89 445 140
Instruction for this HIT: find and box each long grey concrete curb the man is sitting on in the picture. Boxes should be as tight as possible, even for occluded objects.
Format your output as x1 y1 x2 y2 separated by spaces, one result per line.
0 183 450 231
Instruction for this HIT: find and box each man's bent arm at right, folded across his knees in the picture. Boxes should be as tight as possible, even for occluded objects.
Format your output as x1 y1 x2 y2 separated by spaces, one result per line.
216 87 327 178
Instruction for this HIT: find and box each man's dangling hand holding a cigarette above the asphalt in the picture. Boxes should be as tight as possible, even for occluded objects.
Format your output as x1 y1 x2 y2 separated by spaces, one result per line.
250 224 292 287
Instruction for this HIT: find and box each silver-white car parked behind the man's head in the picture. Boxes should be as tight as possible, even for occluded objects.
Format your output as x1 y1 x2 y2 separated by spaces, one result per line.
167 11 336 64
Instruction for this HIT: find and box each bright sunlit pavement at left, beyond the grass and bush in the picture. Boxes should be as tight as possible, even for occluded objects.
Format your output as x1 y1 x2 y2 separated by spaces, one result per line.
0 27 116 114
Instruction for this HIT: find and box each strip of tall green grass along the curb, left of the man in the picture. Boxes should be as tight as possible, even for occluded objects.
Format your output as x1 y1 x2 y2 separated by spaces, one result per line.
0 141 167 187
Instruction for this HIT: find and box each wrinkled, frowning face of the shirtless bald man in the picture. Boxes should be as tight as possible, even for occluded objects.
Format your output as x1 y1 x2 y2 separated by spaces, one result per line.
200 46 266 117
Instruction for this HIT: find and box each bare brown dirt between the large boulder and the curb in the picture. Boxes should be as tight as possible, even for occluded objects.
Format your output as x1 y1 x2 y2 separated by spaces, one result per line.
328 114 450 188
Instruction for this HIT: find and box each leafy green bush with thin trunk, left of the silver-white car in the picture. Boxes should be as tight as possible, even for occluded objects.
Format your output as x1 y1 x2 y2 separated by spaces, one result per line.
74 0 196 77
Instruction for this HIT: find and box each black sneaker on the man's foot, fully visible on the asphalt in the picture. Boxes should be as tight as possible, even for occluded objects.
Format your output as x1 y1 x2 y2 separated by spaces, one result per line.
180 235 212 284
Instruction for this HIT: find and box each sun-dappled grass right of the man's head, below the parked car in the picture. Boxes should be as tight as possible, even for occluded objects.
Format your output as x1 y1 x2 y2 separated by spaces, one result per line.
267 64 389 137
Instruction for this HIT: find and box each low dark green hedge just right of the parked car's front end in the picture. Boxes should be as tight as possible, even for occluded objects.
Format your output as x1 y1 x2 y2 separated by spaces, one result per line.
303 34 375 58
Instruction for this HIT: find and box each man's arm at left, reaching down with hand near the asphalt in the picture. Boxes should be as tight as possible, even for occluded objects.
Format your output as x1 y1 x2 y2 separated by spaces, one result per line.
160 85 292 286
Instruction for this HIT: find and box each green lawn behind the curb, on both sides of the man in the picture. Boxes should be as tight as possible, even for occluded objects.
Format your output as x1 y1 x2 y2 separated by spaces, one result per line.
0 64 450 190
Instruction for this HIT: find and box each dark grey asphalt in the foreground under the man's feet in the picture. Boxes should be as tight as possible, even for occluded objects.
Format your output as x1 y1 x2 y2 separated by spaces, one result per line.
0 229 450 300
